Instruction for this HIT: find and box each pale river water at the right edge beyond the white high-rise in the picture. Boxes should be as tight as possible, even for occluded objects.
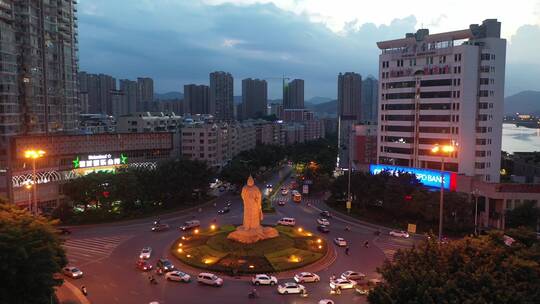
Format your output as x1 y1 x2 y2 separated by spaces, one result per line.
502 124 540 153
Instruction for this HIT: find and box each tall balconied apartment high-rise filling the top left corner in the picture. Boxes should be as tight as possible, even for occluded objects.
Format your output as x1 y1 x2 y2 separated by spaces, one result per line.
0 0 80 166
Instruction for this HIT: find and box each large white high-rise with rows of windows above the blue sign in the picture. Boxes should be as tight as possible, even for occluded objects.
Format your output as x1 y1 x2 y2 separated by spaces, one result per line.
377 19 506 182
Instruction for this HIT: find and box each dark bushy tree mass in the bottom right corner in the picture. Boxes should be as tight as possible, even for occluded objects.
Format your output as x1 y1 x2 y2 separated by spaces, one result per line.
368 232 540 304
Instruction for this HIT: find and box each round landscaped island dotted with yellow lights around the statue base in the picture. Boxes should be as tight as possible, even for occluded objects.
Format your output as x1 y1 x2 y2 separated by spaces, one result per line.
171 225 328 274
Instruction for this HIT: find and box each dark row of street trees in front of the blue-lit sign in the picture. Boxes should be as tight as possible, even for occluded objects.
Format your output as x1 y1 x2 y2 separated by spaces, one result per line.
329 172 474 233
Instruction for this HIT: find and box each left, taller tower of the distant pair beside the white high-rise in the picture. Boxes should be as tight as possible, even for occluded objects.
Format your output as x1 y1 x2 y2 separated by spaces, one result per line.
337 72 362 121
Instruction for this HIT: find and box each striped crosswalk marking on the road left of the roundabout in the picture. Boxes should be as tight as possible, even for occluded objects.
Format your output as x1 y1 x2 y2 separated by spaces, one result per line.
63 235 131 263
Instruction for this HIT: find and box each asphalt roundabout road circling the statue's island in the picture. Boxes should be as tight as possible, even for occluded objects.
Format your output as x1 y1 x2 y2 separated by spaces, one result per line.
61 168 412 304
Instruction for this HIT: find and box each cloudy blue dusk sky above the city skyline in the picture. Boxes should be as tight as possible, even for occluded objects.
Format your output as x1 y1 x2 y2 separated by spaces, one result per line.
78 0 540 98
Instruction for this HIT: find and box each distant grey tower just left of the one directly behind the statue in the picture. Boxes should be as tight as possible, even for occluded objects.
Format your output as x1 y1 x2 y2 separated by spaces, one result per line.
209 72 234 121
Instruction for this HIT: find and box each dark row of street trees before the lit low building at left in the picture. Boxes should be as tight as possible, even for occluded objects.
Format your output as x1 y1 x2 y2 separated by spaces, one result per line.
53 159 215 223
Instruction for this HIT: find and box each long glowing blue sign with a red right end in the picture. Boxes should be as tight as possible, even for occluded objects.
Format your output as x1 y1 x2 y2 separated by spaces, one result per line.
369 165 457 191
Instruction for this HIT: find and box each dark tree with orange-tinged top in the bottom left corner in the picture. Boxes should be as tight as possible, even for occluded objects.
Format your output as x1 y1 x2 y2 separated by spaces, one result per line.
0 204 67 304
